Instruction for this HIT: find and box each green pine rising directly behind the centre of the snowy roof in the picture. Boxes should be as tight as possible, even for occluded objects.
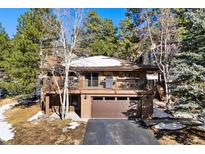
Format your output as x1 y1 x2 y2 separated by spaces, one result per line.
80 11 117 56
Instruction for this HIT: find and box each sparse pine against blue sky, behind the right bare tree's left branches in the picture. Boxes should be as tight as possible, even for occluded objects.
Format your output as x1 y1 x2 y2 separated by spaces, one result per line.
126 8 160 55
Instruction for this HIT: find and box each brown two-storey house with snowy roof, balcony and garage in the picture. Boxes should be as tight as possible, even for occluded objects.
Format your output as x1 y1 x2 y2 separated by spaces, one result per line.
42 56 157 119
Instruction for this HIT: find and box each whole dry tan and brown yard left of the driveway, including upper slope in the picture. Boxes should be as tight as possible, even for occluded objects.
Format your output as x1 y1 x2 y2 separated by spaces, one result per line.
5 100 86 145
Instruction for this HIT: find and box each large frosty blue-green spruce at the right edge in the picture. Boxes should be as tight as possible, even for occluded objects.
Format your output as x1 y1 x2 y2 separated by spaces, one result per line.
172 9 205 113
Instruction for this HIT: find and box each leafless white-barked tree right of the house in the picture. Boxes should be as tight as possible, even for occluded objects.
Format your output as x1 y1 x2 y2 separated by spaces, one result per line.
144 9 178 105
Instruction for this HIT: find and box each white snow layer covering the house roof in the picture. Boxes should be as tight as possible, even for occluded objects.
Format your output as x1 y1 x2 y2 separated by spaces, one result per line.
71 56 123 67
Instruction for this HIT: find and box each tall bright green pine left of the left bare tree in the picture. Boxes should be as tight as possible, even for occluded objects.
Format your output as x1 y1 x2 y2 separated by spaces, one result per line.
4 9 58 94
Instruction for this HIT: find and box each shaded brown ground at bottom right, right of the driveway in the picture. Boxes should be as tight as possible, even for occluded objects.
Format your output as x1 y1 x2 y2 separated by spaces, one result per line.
150 129 205 145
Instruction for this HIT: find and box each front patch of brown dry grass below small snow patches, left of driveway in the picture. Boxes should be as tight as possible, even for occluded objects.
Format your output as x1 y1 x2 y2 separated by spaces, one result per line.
7 120 86 145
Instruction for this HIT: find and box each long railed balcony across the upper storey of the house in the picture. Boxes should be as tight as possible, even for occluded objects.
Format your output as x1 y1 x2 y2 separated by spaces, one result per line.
46 76 145 92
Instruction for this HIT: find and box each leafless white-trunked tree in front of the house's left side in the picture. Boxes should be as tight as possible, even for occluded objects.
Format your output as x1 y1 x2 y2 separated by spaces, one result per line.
42 9 84 119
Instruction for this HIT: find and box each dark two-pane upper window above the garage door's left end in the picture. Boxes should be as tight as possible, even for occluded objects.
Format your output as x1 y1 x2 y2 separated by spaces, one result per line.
85 72 99 87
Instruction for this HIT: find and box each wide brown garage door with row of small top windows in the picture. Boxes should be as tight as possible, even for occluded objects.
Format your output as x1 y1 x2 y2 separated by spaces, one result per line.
91 97 141 119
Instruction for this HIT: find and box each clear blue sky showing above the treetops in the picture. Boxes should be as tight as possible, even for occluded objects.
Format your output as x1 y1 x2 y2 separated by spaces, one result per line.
0 8 126 37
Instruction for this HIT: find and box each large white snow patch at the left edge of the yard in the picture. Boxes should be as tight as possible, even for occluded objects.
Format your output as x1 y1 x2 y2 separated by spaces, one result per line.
0 103 17 141
